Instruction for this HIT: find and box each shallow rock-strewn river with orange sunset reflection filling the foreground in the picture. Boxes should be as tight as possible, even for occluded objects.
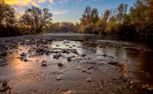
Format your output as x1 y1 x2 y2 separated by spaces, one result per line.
0 34 153 94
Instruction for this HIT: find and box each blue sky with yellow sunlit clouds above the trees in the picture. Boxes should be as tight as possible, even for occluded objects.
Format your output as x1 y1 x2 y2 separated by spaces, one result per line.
5 0 135 23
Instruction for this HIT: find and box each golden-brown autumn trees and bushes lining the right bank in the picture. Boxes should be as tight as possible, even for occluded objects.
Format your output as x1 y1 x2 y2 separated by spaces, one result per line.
80 0 153 42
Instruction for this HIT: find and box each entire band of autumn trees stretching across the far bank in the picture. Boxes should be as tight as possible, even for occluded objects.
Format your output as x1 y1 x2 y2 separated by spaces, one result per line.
0 0 153 43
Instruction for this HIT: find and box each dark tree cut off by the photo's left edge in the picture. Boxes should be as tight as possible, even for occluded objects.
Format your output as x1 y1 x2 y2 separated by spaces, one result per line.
0 3 16 36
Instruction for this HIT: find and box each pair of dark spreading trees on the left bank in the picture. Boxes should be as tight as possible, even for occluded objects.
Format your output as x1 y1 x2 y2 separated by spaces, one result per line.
0 3 52 36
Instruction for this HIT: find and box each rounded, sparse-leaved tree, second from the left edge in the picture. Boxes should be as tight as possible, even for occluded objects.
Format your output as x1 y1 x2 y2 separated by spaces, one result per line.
21 7 52 33
